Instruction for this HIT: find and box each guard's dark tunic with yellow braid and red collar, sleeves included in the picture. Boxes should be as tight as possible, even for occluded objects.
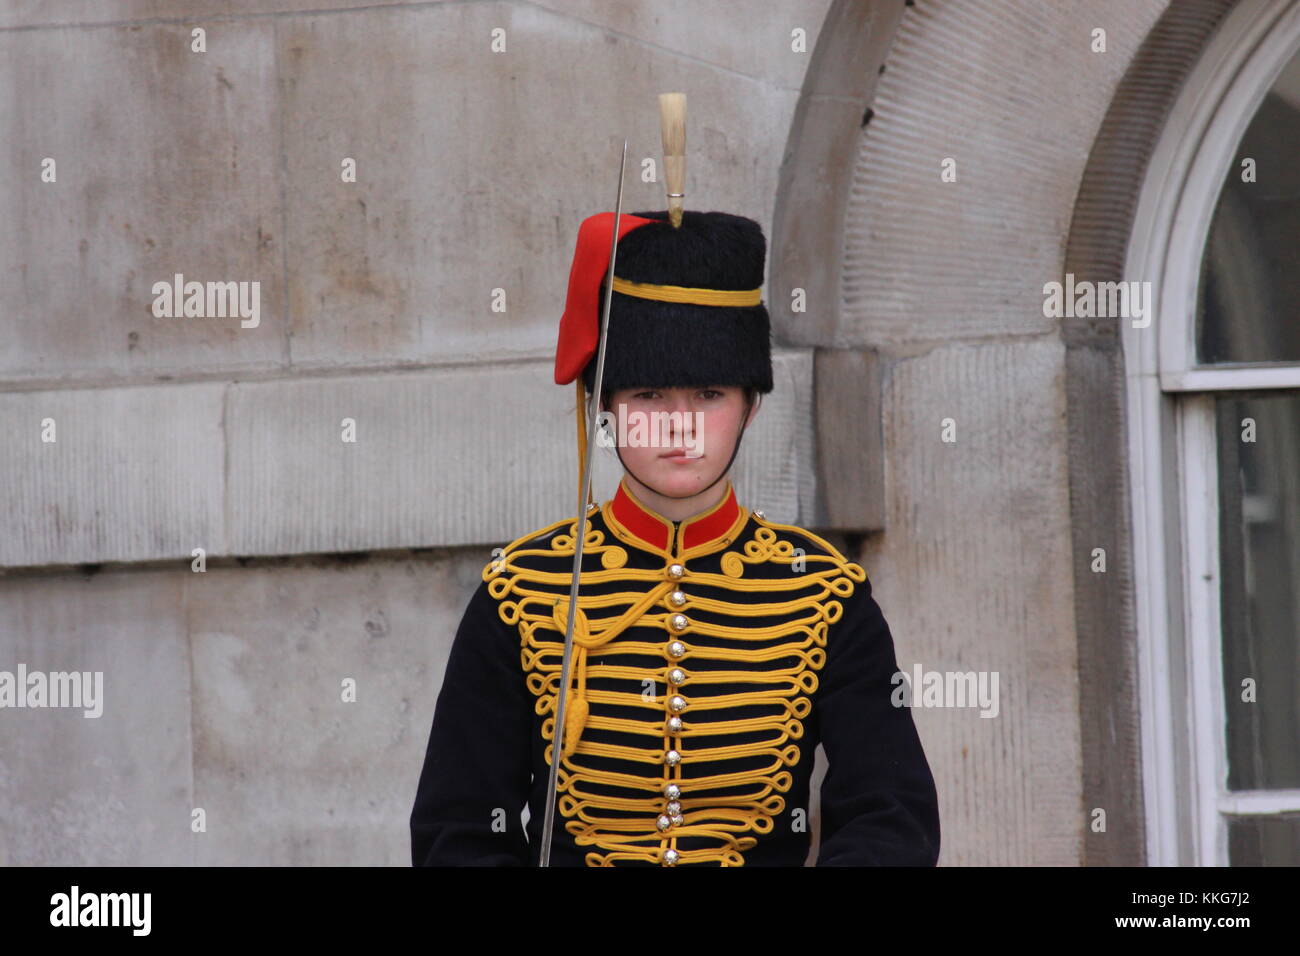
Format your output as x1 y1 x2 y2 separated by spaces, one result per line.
411 483 939 866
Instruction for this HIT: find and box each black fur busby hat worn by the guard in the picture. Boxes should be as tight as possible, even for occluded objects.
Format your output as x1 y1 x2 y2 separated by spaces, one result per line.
582 209 772 393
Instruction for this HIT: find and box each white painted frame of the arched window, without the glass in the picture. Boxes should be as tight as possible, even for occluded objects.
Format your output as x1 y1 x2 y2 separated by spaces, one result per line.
1121 0 1300 866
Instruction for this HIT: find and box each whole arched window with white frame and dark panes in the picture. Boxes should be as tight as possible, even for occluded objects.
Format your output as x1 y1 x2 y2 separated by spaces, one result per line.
1123 0 1300 865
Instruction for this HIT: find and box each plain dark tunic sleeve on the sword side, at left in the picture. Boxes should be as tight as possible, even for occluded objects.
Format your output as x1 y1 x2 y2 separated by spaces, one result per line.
411 574 533 866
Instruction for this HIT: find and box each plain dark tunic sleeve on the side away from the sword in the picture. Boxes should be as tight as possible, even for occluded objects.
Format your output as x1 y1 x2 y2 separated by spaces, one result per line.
816 580 939 866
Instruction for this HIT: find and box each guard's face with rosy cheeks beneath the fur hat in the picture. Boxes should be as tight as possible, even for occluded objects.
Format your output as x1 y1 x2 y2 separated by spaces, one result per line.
607 385 745 497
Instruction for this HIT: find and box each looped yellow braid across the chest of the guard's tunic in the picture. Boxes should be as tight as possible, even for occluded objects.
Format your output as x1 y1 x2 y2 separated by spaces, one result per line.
484 505 866 866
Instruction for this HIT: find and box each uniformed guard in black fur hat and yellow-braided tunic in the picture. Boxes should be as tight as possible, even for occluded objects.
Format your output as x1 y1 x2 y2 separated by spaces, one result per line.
411 211 940 866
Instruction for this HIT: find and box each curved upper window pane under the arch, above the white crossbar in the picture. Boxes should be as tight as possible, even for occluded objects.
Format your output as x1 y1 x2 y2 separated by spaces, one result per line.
1196 55 1300 364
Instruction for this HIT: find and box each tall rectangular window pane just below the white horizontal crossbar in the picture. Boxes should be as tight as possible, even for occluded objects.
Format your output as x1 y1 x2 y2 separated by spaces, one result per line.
1216 392 1300 790
